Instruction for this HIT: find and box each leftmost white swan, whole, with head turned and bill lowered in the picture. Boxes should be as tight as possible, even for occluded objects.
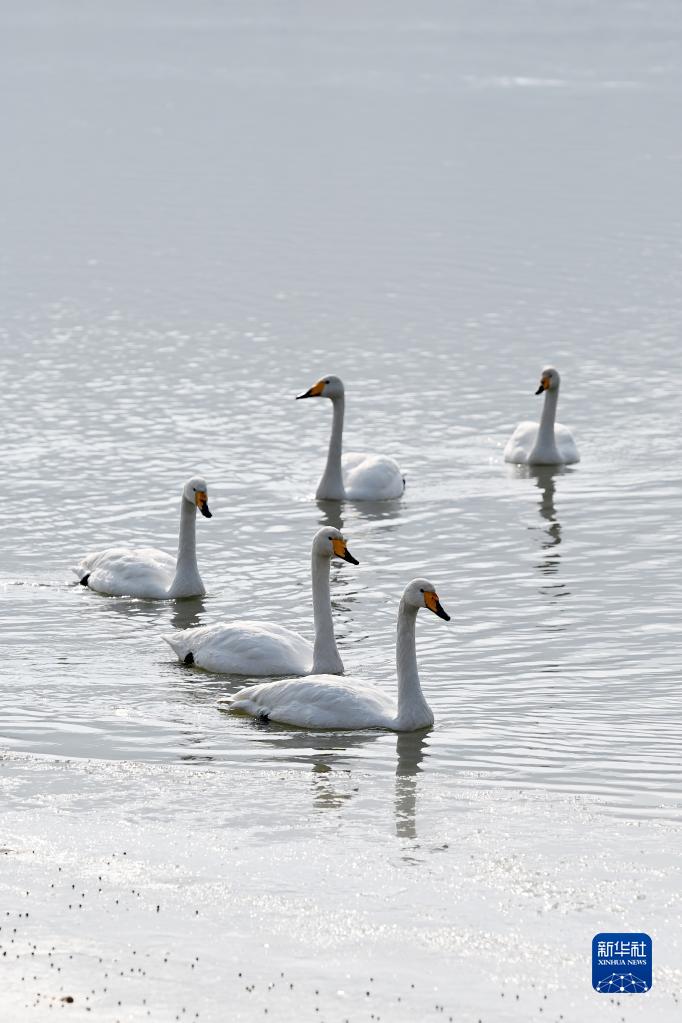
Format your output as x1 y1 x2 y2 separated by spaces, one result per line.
74 478 211 601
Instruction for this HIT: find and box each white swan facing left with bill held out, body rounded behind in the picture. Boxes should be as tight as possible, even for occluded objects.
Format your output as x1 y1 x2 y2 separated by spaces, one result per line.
297 376 405 501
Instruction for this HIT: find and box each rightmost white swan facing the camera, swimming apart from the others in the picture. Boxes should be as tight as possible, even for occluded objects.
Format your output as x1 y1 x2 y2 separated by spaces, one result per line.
504 366 580 465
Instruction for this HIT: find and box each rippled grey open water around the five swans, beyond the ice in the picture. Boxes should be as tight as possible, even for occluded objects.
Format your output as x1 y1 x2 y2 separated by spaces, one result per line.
0 2 682 818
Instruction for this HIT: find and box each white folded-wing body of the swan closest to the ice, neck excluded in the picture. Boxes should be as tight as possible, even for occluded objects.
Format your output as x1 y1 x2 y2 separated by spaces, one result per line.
225 675 396 728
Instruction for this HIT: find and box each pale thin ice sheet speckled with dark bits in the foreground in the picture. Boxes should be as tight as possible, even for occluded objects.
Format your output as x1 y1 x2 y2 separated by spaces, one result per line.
0 756 682 1023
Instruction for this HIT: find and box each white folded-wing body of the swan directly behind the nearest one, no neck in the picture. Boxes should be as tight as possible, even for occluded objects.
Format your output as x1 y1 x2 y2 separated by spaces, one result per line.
162 621 313 676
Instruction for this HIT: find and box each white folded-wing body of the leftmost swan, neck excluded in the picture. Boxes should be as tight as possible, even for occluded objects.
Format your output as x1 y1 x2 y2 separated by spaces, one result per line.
75 547 176 599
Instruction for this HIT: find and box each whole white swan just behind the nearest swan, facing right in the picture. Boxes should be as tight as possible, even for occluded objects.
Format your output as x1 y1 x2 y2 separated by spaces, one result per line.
162 527 359 675
